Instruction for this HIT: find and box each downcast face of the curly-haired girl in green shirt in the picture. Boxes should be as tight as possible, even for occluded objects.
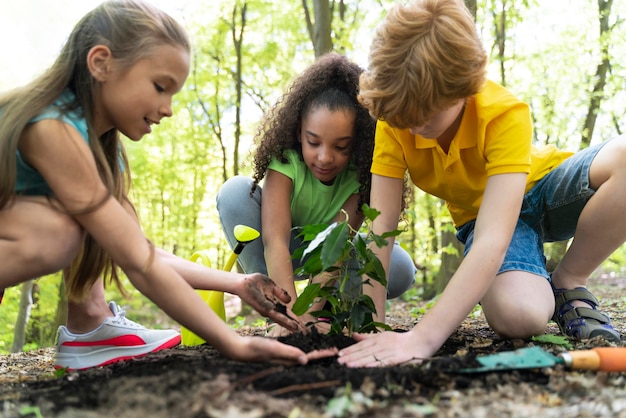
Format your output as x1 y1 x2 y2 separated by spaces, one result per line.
300 108 356 184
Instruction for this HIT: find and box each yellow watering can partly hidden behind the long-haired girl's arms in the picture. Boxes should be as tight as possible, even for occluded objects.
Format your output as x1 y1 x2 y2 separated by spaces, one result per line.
180 225 260 346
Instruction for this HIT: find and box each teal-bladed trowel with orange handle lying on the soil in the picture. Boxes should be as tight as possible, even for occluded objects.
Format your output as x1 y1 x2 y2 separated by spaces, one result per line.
458 347 626 373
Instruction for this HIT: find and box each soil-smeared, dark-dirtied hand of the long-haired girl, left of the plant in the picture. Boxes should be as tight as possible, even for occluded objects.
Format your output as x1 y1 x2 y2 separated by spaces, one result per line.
236 273 304 332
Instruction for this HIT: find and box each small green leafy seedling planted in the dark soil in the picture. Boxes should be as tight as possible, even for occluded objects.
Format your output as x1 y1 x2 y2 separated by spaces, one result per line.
292 205 400 336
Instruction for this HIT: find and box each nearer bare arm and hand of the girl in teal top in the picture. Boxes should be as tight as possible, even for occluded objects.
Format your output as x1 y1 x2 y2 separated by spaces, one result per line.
20 120 314 362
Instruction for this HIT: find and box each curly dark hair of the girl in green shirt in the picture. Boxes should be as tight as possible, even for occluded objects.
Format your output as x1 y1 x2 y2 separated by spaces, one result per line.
251 52 376 210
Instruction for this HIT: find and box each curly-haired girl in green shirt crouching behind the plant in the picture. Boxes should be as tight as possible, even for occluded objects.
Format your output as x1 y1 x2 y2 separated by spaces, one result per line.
217 53 416 336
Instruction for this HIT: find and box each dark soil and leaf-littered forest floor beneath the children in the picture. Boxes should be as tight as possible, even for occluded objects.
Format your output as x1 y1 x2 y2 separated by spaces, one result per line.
0 276 626 418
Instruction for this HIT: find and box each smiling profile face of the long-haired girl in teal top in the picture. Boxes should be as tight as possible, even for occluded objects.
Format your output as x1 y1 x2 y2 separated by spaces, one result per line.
95 44 189 141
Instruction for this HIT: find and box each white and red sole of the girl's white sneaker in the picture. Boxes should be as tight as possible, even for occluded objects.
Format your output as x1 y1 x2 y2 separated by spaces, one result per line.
54 335 180 371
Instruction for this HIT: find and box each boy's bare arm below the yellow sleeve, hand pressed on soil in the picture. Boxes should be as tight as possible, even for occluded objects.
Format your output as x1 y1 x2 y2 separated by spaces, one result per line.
340 173 526 366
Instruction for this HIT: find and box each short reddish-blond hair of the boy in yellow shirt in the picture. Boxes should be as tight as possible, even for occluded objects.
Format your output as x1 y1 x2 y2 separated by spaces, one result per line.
359 0 487 128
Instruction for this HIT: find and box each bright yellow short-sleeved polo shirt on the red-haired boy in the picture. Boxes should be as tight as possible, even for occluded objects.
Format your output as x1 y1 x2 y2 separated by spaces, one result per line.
372 81 573 227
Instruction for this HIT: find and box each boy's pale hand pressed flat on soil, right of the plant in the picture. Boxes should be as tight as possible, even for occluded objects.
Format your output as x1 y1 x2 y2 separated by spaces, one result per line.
338 331 428 367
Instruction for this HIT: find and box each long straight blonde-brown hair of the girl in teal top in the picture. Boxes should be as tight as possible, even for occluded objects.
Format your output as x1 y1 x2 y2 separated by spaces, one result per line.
0 0 190 300
